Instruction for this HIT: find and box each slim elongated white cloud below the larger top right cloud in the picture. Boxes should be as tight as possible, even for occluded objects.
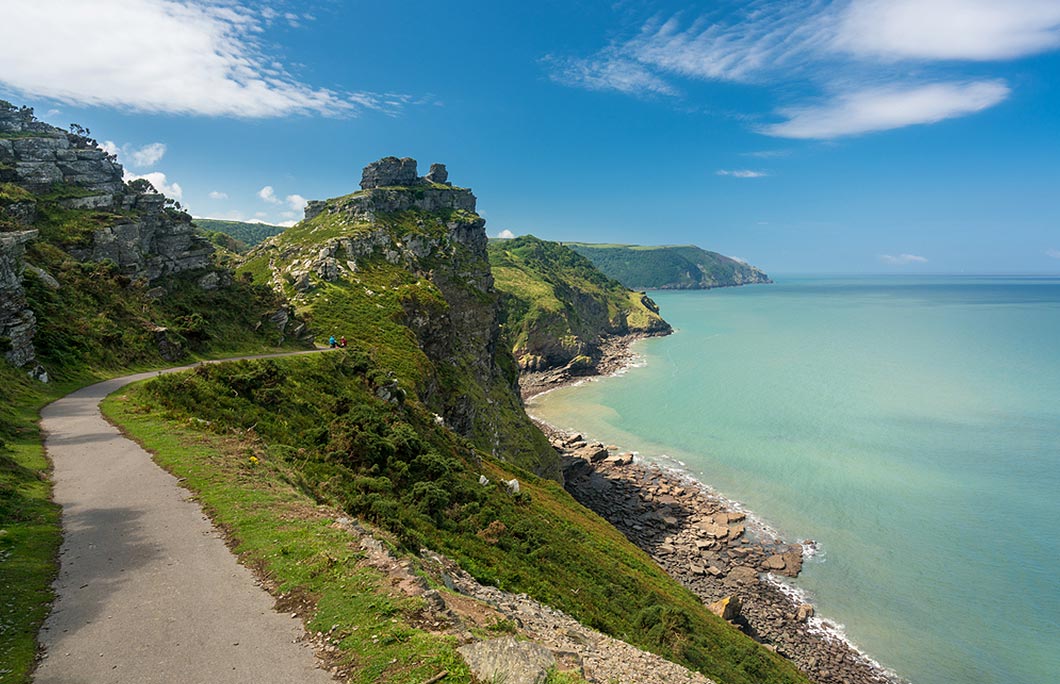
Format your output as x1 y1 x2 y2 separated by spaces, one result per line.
759 81 1010 139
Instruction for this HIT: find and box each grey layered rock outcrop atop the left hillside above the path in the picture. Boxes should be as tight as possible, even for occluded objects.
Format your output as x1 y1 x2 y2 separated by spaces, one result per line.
0 100 214 379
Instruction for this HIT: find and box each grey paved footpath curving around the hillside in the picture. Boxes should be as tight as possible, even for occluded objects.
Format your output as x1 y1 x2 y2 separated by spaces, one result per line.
34 350 334 684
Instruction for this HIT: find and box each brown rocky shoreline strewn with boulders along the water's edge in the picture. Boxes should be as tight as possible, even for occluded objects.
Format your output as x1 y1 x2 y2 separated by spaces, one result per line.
519 335 904 684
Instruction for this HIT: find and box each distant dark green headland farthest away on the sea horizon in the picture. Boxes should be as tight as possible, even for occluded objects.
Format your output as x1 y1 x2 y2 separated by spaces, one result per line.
564 242 772 290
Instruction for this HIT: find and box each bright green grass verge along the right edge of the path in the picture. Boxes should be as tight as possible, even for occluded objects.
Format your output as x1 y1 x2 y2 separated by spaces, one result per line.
104 388 471 684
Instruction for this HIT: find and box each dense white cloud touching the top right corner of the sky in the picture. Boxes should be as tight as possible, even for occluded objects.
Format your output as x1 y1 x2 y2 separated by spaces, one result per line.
833 0 1060 60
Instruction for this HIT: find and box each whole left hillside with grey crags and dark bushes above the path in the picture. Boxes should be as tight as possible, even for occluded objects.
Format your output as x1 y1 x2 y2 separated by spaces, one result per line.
0 101 304 380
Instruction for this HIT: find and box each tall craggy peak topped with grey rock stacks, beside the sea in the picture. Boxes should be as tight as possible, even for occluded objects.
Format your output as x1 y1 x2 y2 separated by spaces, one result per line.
242 158 559 478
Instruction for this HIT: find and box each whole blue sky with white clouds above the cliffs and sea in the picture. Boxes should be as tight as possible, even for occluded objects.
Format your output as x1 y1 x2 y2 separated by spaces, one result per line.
0 0 1060 274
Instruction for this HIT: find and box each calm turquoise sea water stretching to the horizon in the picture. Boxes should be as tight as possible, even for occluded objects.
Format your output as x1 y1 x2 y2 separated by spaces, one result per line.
529 277 1060 684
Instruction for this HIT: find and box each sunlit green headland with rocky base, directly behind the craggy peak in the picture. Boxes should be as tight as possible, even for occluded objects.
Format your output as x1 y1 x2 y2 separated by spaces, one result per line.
490 235 670 370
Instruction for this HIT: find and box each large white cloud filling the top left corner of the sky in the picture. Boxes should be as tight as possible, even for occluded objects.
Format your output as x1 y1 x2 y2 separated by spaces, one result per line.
0 0 410 118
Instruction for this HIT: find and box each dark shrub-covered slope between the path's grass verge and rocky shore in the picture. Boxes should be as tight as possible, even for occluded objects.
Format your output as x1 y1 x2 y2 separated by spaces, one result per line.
111 352 805 683
